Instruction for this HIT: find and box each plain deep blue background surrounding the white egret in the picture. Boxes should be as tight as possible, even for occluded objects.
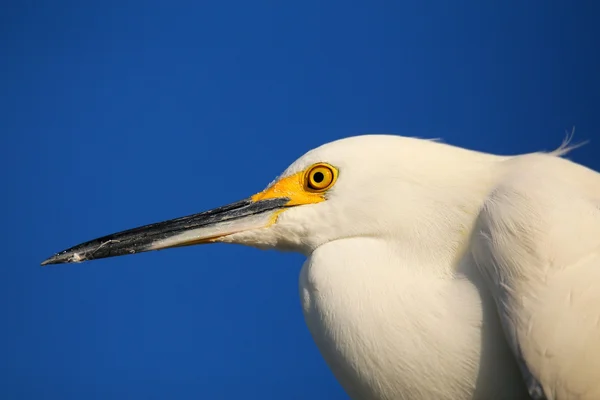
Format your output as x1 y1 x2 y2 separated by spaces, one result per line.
0 0 600 399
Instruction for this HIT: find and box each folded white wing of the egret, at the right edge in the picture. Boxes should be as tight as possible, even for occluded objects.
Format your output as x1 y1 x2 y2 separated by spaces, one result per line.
470 154 600 399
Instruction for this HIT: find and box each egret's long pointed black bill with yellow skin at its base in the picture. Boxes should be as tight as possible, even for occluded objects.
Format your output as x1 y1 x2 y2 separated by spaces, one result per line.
42 170 324 265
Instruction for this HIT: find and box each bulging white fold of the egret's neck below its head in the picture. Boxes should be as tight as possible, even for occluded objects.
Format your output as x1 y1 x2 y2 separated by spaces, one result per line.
300 238 516 399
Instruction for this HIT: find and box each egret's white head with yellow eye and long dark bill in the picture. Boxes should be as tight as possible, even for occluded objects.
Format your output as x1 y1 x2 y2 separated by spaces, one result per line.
43 135 492 265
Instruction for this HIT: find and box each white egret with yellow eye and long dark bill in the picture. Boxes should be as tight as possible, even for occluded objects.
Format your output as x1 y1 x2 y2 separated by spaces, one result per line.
43 135 600 400
